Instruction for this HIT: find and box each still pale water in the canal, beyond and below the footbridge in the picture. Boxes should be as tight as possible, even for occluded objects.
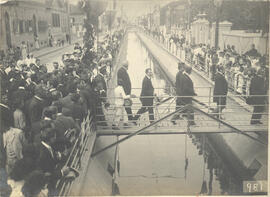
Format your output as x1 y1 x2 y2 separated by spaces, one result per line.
116 32 243 195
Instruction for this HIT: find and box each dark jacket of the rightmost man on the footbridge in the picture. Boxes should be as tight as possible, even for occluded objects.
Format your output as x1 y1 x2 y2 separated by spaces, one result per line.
249 76 266 105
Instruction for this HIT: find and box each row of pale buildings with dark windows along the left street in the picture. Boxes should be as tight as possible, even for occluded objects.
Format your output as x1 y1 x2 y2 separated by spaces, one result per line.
0 0 84 51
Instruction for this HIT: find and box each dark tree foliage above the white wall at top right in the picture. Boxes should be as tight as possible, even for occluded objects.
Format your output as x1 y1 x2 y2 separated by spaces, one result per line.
188 0 269 32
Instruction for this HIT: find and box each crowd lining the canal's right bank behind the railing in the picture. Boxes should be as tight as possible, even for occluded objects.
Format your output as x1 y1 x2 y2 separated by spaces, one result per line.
148 27 269 96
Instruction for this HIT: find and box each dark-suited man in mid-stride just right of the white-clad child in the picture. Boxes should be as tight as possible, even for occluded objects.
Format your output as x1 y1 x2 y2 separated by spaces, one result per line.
134 68 154 123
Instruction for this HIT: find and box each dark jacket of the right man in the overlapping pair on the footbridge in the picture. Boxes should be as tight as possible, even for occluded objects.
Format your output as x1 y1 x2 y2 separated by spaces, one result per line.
182 74 196 105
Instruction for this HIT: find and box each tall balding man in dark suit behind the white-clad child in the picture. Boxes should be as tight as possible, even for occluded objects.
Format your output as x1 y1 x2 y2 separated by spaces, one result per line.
117 61 133 121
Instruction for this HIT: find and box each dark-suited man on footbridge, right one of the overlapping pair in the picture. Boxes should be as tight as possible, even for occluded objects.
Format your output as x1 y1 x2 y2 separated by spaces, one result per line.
181 66 197 125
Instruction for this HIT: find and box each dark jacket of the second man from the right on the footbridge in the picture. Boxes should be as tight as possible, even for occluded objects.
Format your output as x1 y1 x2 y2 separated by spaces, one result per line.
213 73 228 105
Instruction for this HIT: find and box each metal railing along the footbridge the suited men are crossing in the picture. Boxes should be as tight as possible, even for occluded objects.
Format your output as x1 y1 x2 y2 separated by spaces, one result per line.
96 91 268 129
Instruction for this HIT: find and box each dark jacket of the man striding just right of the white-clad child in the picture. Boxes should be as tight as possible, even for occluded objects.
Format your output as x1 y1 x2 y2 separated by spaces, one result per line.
140 76 154 106
